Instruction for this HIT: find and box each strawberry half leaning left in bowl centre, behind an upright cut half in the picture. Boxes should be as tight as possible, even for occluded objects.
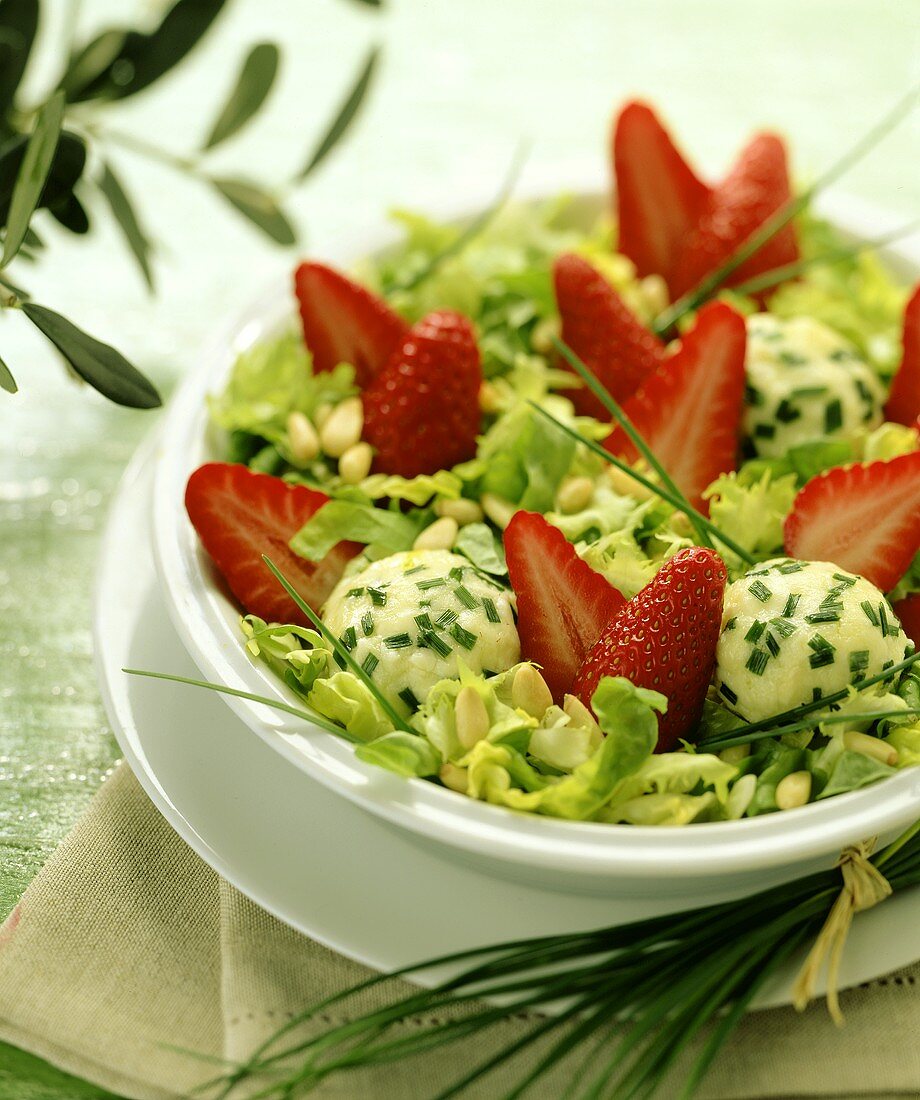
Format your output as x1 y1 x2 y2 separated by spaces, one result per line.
552 253 665 420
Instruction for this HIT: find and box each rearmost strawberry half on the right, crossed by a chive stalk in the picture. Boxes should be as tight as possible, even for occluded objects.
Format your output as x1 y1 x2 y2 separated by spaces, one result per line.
670 133 799 297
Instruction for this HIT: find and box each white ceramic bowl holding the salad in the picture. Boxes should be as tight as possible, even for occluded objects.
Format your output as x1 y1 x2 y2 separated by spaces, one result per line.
153 183 920 905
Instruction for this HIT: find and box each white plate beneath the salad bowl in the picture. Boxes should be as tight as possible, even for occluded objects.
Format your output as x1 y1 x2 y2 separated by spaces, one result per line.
94 429 920 1008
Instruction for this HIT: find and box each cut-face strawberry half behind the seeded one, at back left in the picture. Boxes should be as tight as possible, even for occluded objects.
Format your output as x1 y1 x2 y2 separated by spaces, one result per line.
294 263 408 389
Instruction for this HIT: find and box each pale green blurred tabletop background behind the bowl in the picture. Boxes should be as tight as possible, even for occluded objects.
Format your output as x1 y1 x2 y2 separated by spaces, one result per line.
0 0 920 1100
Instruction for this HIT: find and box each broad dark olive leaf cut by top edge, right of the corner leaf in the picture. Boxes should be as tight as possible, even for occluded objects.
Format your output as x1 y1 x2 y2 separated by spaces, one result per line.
68 0 224 102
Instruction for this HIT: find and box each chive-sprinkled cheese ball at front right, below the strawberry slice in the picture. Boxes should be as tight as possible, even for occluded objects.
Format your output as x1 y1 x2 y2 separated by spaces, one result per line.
715 558 908 722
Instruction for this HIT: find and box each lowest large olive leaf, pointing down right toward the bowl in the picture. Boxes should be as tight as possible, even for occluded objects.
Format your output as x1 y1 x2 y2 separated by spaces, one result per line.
20 301 161 409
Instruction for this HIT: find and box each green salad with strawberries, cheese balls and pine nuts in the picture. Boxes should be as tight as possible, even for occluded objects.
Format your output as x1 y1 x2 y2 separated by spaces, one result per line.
186 102 920 825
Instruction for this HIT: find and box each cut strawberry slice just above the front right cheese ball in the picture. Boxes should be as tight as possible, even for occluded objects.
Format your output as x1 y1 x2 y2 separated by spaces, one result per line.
784 451 920 592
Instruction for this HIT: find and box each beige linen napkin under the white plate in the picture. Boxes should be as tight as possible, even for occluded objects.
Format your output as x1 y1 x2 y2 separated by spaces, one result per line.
0 765 920 1100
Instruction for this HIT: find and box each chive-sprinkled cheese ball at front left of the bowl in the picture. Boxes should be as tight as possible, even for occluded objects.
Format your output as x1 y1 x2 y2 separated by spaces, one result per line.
322 550 521 713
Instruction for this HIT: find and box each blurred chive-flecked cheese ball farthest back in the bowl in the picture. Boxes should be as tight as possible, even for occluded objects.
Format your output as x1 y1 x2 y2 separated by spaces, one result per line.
744 314 885 459
